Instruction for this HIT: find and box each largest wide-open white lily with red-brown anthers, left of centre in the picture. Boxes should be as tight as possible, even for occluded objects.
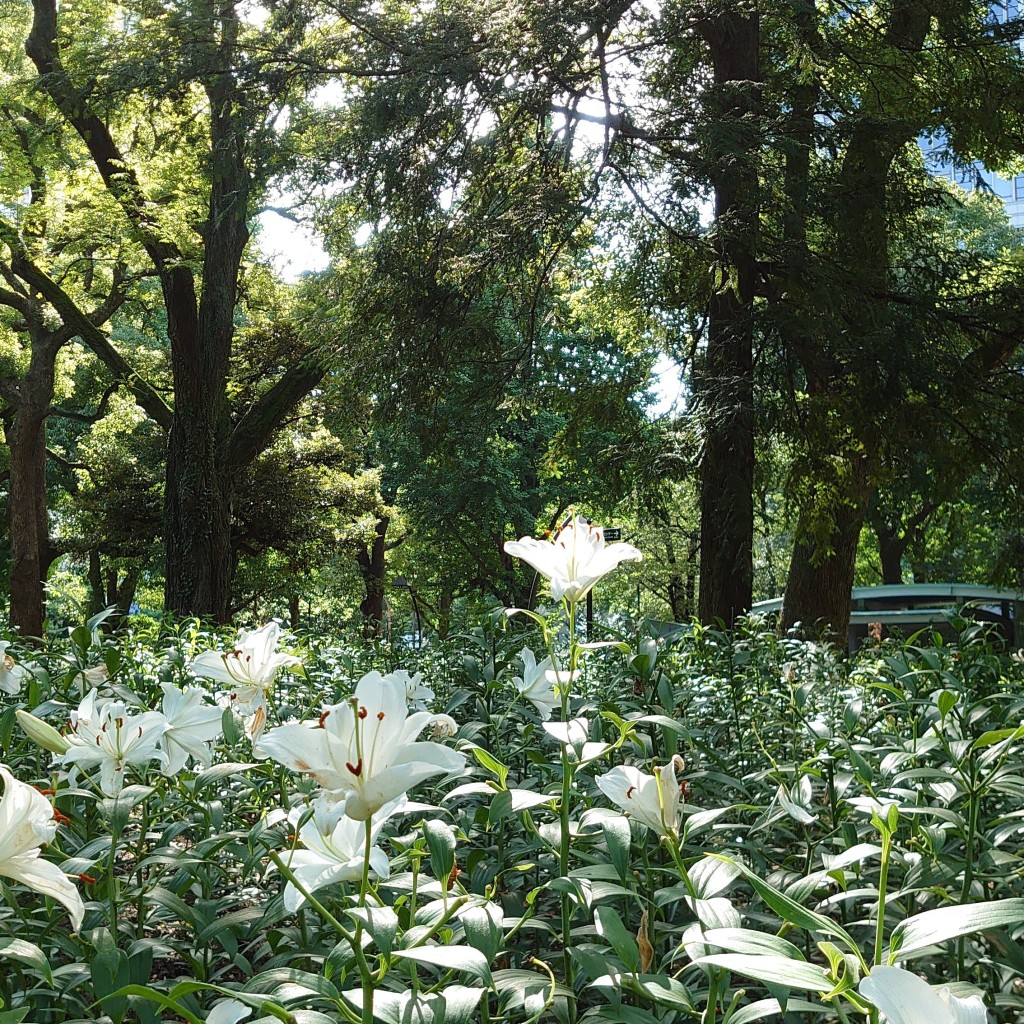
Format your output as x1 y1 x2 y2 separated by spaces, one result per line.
260 672 465 821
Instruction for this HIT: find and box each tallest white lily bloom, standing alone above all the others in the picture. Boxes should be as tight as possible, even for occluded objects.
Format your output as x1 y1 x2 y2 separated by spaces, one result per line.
505 516 643 604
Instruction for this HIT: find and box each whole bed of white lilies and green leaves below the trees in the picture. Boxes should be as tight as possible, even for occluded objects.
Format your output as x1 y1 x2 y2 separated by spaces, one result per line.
0 519 1024 1024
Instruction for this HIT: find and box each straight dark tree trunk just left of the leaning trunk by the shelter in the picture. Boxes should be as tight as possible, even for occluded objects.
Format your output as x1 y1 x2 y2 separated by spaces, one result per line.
697 9 761 626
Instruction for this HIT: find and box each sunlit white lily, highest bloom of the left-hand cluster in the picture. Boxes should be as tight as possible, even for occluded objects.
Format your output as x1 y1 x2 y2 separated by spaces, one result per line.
188 622 302 742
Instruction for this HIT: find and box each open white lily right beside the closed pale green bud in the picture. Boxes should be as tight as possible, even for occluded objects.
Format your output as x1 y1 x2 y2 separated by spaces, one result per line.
55 690 167 797
